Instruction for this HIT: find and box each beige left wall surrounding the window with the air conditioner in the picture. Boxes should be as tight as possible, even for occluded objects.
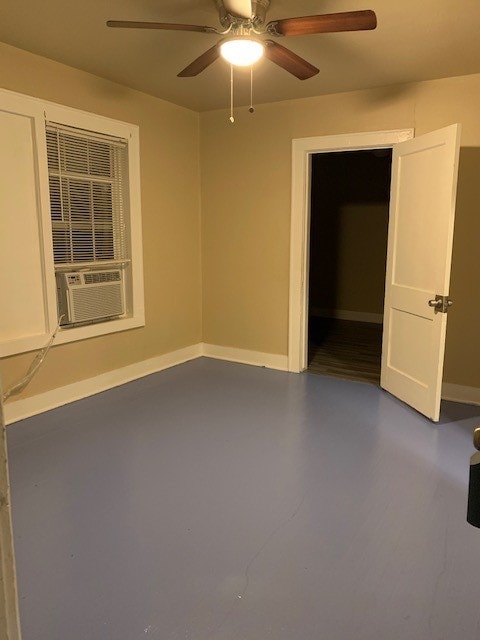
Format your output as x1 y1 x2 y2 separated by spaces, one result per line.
0 44 201 397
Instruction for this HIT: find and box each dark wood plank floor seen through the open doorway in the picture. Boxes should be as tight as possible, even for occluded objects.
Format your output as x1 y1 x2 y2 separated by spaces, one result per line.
308 317 383 384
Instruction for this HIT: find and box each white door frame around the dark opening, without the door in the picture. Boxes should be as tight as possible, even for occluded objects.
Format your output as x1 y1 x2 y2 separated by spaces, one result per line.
288 129 414 372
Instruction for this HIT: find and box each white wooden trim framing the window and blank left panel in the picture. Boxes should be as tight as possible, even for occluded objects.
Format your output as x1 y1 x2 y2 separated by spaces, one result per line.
0 90 145 357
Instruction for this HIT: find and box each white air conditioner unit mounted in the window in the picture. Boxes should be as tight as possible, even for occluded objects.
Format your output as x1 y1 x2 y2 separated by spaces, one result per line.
56 269 125 325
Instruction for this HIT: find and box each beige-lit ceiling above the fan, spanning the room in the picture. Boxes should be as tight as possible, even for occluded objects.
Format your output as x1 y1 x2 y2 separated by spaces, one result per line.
0 0 480 111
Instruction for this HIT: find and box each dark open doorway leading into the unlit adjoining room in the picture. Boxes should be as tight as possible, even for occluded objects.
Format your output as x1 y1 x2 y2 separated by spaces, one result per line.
307 148 392 385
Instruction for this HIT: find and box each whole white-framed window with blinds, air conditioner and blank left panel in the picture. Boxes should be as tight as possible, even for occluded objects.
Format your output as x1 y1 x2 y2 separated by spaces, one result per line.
0 89 145 357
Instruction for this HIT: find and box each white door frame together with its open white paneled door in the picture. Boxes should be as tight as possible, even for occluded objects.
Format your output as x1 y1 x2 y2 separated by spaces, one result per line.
288 123 461 422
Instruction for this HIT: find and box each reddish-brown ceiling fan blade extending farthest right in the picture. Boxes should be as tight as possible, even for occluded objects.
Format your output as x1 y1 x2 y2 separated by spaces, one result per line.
267 10 377 36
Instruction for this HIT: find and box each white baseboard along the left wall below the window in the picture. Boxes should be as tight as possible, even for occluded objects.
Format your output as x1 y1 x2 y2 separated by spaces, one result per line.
5 344 202 424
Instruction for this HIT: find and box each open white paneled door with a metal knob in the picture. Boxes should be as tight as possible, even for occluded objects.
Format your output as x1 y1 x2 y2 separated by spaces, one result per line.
381 125 460 421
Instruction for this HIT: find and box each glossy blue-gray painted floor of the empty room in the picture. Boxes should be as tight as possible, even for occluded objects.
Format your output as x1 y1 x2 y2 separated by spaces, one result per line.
8 359 480 640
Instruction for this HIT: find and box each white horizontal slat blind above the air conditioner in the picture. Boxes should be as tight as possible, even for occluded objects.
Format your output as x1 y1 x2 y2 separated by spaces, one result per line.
46 122 129 267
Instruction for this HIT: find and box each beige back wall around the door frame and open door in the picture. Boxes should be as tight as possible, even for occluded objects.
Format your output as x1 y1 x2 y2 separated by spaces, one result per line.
201 75 480 387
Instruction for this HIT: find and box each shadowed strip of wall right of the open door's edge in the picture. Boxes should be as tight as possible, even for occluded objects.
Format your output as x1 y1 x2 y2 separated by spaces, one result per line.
444 147 480 389
